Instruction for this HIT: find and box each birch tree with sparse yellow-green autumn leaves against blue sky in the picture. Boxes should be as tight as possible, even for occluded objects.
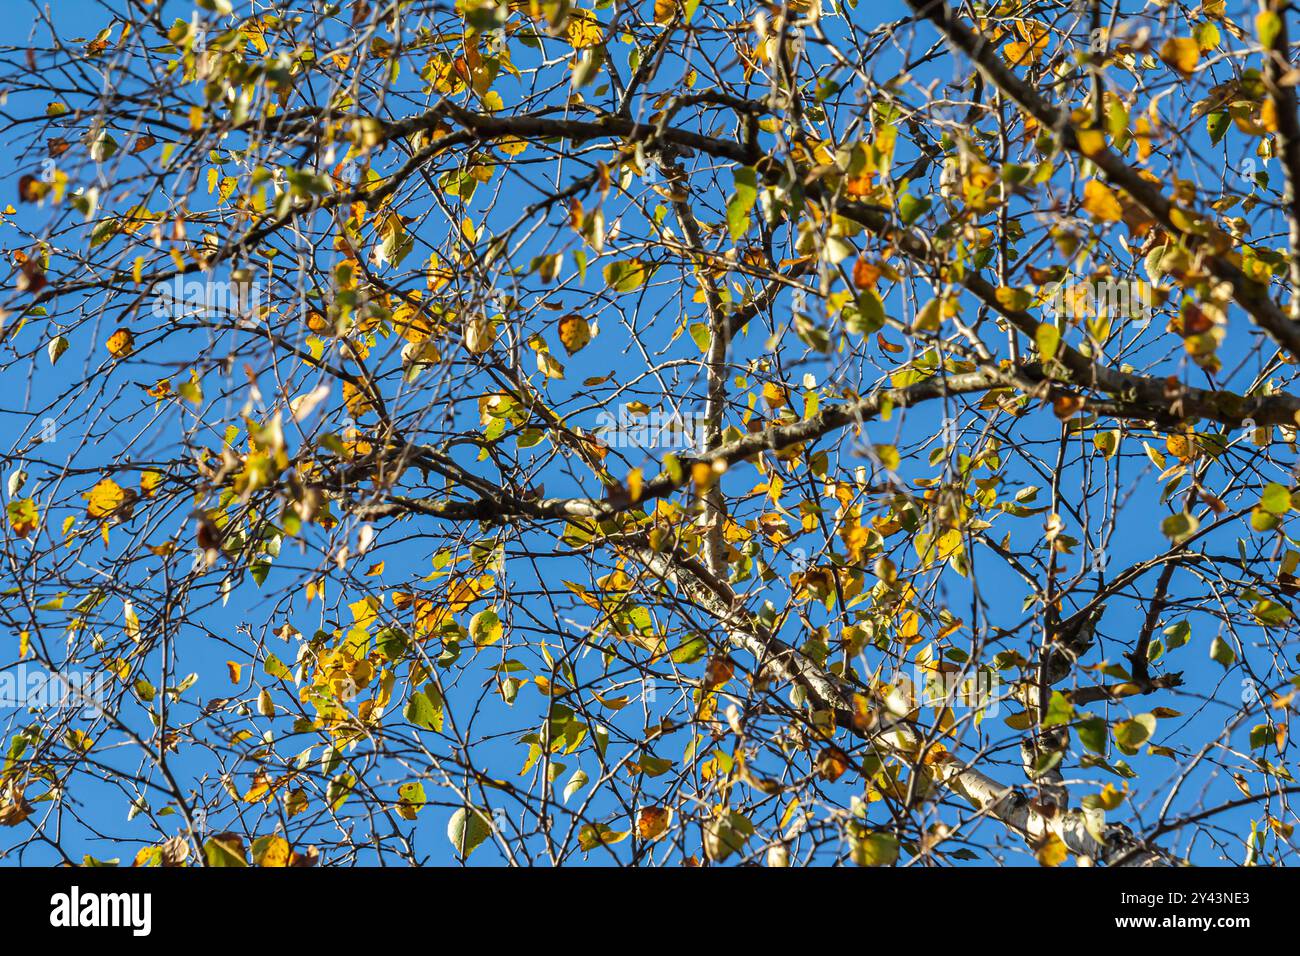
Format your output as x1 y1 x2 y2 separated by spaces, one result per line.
0 0 1300 865
